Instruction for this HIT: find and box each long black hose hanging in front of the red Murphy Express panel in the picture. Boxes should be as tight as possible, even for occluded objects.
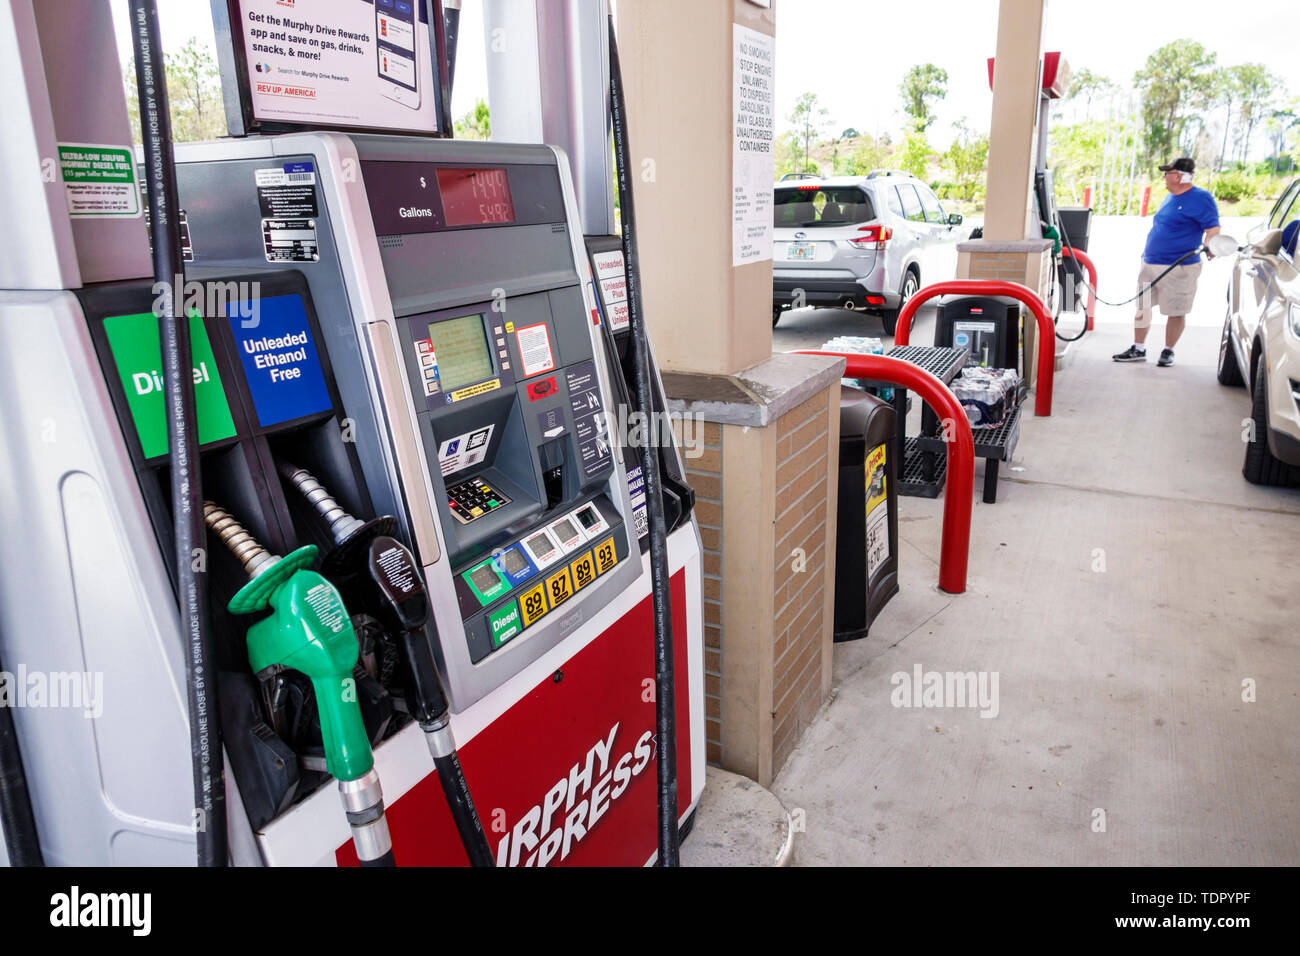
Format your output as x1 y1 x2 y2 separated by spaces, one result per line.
610 16 679 866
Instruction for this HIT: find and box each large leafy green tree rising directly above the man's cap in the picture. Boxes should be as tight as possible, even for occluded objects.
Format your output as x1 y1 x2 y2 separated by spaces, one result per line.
1134 39 1214 166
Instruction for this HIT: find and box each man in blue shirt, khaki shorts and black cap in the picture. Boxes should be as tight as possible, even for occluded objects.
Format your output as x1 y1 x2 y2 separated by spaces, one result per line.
1113 156 1219 367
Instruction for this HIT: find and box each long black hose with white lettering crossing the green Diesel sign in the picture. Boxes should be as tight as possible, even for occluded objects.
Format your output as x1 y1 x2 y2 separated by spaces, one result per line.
129 0 228 866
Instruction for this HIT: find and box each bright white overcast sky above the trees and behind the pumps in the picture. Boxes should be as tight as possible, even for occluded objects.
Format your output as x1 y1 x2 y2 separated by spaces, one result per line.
105 0 1300 153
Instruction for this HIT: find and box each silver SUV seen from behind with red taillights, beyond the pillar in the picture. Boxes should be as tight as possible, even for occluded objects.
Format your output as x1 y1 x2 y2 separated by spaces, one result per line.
772 169 971 336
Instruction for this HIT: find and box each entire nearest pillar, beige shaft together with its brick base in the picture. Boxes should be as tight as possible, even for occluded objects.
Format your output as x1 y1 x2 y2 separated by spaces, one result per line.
618 0 844 786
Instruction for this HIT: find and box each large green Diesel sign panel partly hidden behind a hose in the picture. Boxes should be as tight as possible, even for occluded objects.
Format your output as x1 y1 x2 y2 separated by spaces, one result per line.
104 312 235 458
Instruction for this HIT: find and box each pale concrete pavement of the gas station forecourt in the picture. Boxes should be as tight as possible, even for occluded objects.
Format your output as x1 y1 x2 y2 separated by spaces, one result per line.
772 221 1300 865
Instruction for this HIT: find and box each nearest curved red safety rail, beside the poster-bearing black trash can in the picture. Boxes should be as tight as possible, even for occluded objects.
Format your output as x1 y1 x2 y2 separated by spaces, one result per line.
798 351 975 594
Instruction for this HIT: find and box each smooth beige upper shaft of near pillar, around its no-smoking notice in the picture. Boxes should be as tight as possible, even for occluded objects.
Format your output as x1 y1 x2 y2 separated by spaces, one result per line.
618 0 776 373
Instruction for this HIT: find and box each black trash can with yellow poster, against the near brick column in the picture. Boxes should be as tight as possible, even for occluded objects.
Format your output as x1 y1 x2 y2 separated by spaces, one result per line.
835 388 898 641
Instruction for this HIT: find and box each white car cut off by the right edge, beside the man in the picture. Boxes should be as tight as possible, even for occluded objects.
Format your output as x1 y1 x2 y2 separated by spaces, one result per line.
1218 179 1300 485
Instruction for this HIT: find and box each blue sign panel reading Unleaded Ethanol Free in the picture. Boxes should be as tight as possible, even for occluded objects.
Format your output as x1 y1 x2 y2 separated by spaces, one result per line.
226 295 334 427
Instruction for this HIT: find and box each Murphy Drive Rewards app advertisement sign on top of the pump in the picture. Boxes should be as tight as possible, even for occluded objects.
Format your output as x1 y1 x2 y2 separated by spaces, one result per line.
230 0 438 133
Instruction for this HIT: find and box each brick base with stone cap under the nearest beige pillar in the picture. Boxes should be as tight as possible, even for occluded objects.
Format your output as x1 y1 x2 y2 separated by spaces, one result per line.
663 355 844 786
